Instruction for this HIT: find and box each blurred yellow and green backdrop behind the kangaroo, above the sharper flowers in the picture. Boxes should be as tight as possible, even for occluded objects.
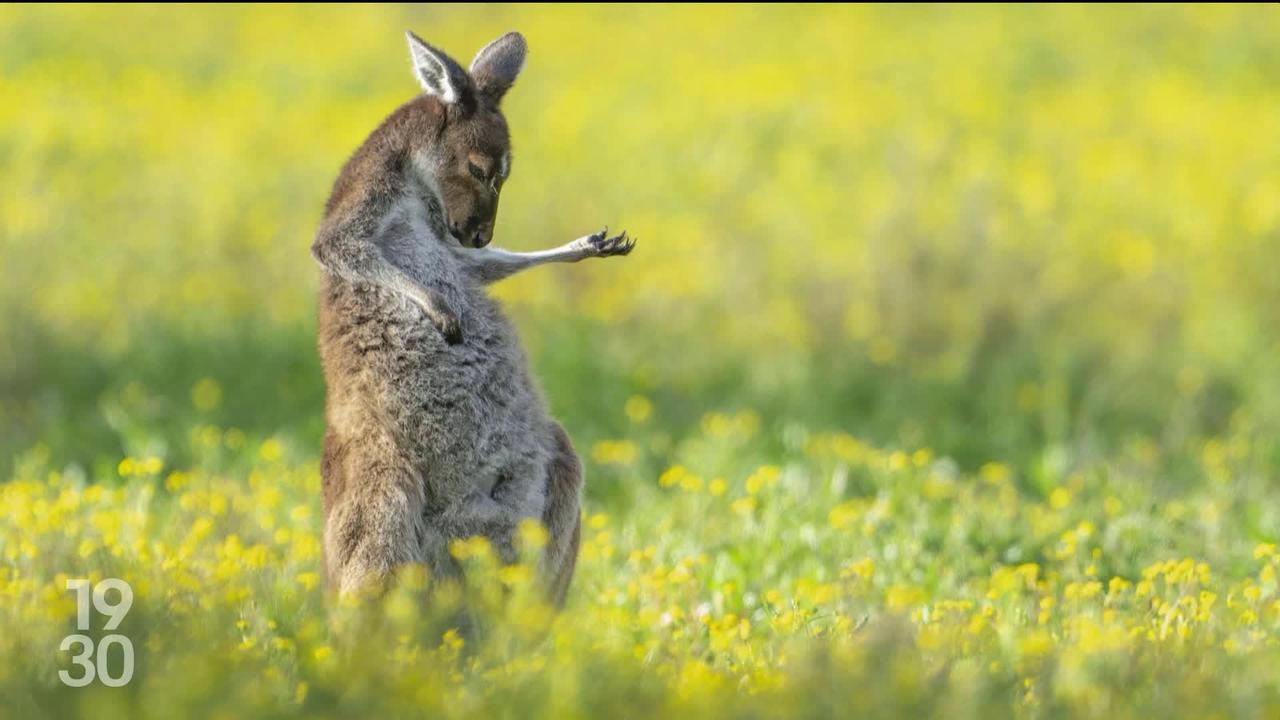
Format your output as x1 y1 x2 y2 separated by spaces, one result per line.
0 5 1280 497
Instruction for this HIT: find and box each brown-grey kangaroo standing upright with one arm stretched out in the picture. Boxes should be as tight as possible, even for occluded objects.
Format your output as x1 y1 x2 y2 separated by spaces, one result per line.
311 32 635 606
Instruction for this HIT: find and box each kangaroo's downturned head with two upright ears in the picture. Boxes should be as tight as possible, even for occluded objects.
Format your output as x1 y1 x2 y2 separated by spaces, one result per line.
407 32 525 247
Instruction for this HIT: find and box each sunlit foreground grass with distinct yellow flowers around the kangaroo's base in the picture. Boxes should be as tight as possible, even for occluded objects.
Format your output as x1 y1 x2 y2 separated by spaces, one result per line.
0 414 1280 717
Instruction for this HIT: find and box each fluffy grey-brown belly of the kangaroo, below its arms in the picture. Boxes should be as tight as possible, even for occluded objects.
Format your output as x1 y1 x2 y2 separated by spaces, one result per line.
321 278 550 516
